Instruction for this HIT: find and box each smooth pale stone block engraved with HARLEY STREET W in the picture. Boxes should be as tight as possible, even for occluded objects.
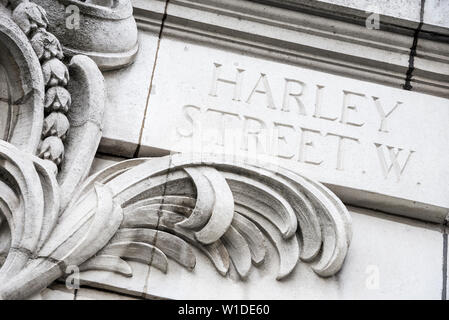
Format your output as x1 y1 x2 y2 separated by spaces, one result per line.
136 39 449 222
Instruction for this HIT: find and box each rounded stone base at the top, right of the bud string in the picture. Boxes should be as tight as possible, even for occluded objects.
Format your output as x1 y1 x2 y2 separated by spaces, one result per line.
34 0 139 70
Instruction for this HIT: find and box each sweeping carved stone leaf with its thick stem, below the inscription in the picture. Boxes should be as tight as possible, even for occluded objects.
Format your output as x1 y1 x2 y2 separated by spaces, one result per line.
0 152 351 299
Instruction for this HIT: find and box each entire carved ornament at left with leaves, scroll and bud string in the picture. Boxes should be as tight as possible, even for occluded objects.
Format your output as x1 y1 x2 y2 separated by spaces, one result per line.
0 0 351 299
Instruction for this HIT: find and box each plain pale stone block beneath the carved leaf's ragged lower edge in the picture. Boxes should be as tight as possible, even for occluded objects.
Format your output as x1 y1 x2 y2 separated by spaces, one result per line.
147 208 443 300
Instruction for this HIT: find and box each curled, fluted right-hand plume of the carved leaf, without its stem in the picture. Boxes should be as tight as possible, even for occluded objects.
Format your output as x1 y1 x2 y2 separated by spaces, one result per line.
76 154 351 280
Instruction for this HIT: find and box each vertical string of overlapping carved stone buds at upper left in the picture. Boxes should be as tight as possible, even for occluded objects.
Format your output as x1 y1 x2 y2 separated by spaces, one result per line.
13 0 71 166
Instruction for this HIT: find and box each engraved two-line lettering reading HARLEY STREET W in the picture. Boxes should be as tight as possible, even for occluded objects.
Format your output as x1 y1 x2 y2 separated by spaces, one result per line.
176 63 422 182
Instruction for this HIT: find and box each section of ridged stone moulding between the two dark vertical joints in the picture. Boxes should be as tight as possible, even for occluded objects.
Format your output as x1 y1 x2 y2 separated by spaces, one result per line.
146 0 412 94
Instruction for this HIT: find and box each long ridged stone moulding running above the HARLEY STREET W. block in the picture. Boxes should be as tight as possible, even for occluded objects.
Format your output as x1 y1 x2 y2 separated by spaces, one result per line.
133 0 449 97
